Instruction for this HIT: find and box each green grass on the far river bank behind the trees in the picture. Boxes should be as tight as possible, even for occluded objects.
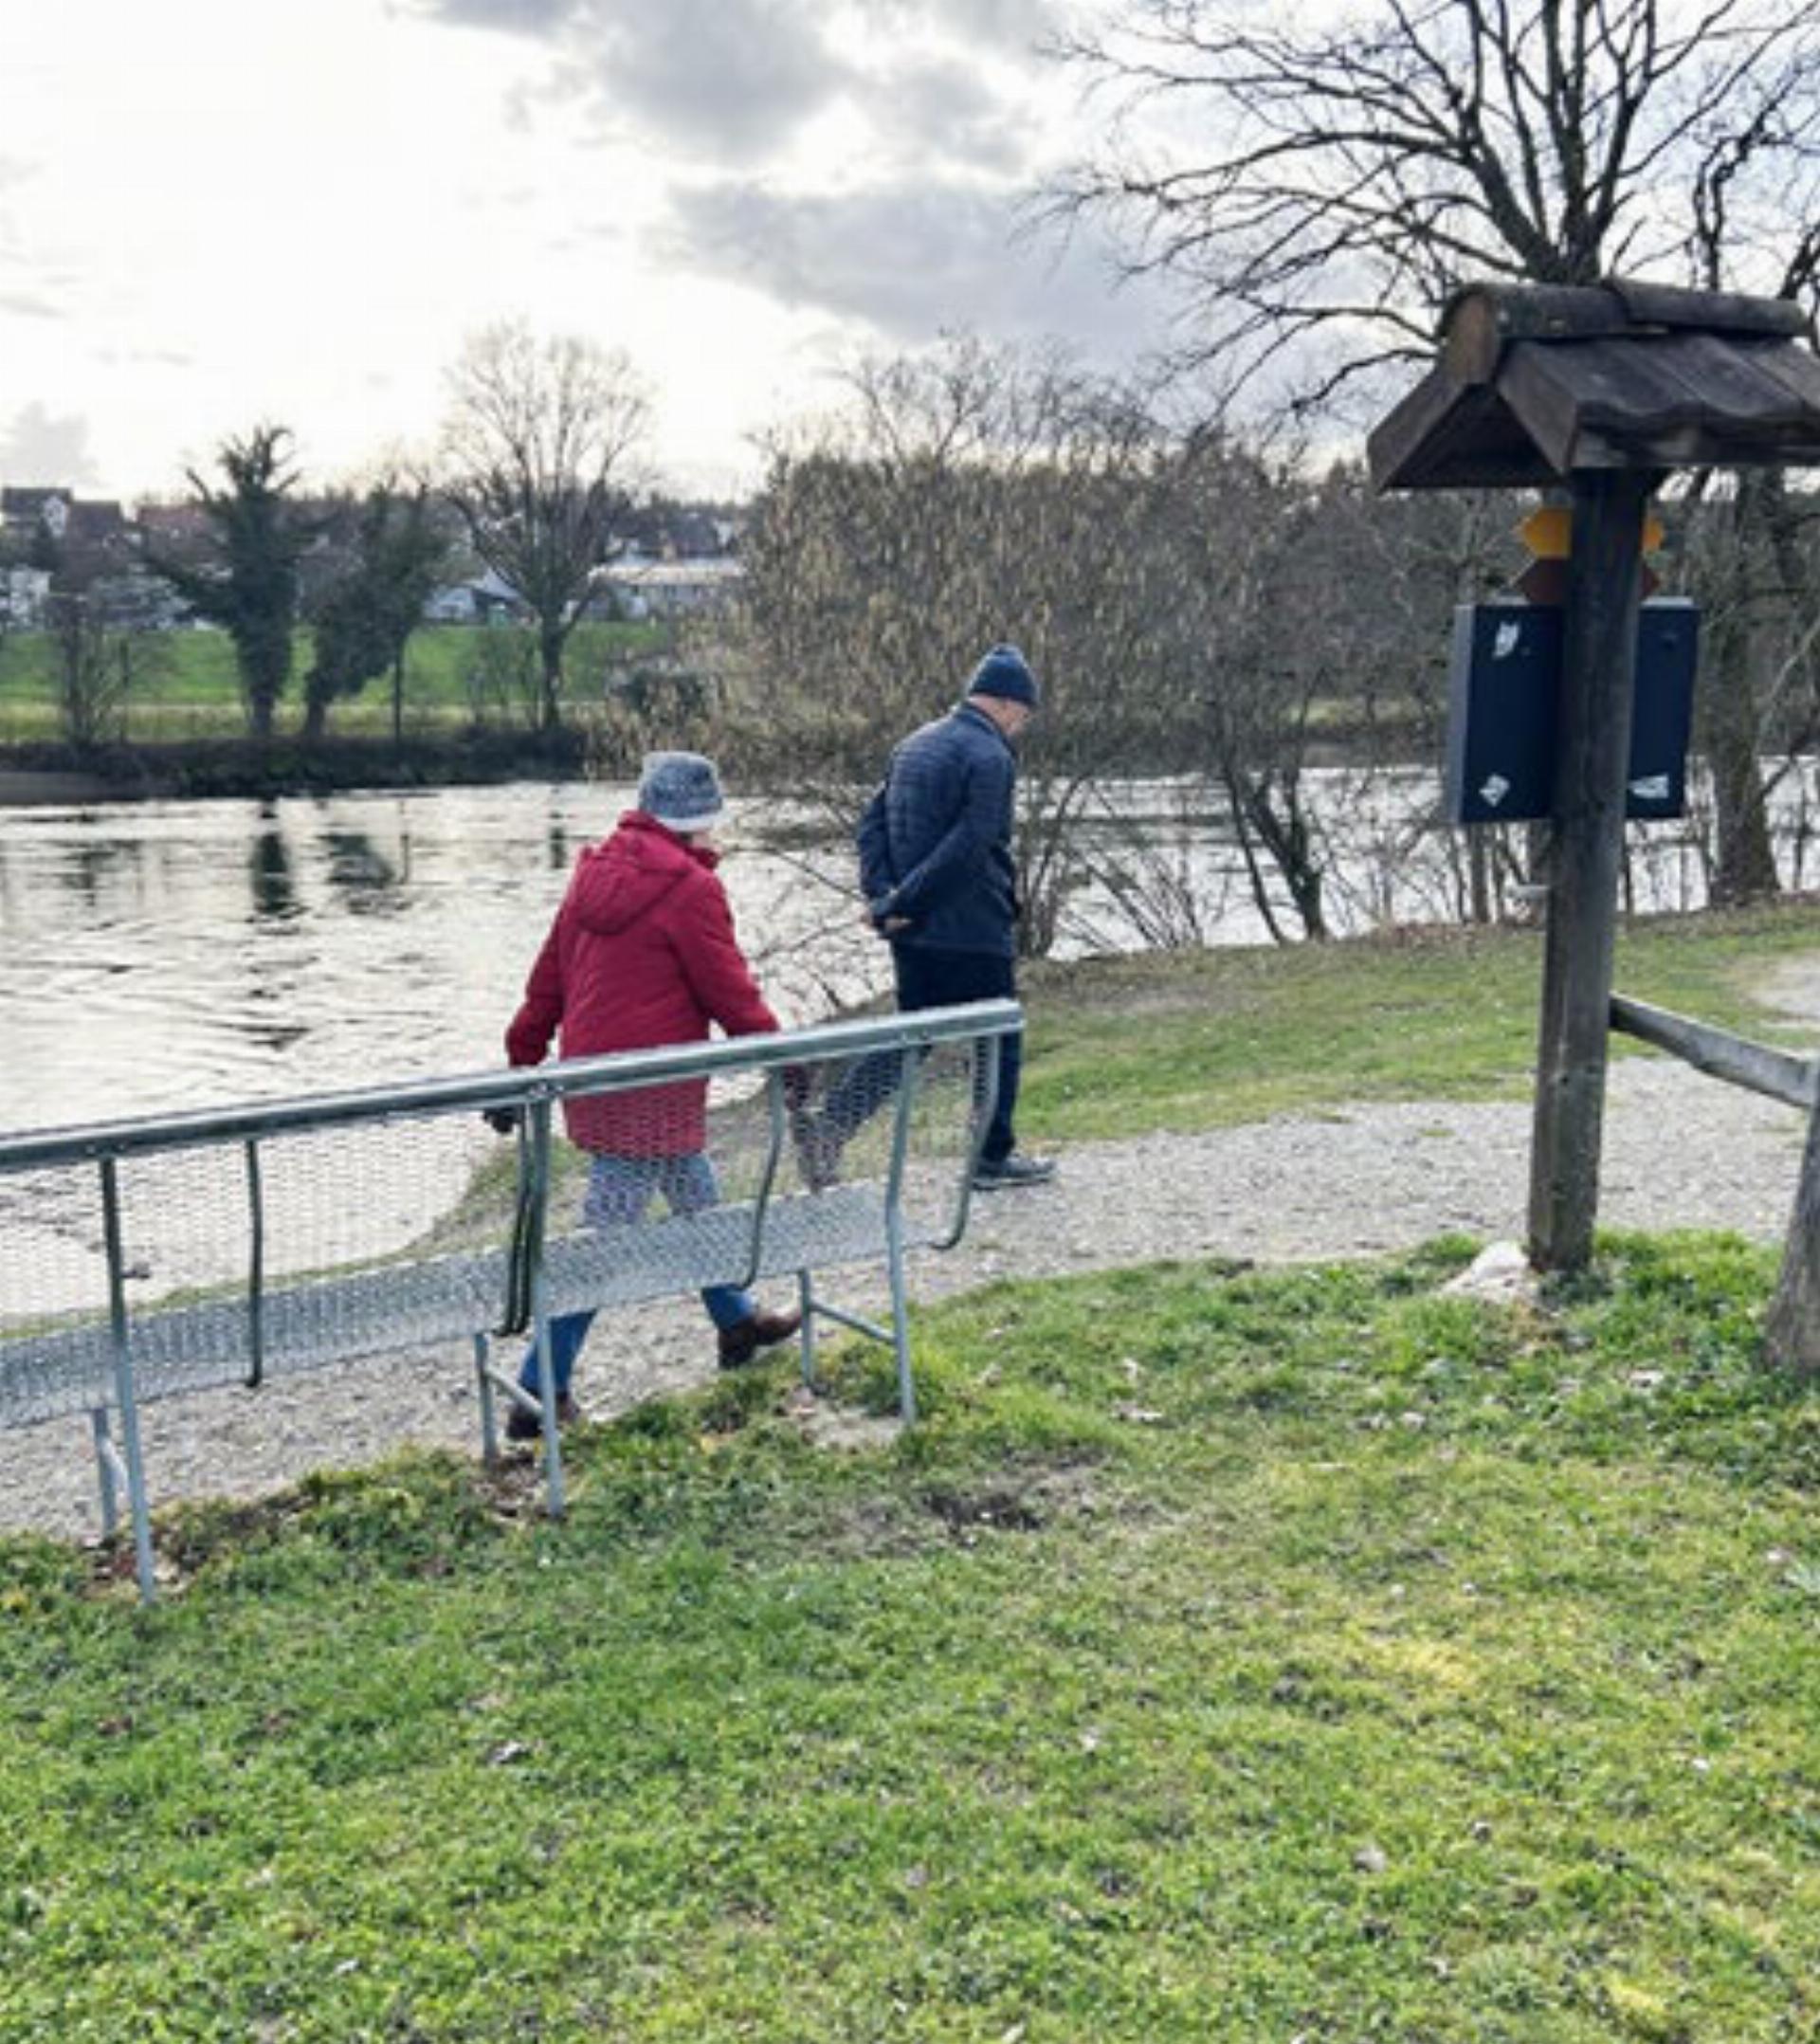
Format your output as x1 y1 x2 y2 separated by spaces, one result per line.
0 624 662 744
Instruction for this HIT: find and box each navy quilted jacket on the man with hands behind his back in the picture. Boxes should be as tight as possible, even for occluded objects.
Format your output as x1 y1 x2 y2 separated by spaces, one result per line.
860 703 1017 958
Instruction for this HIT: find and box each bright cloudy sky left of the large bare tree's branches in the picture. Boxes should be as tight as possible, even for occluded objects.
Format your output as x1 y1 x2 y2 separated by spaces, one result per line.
0 0 1158 497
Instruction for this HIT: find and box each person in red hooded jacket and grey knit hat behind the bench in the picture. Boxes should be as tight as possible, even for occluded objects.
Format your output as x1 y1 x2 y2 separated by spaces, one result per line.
506 752 801 1441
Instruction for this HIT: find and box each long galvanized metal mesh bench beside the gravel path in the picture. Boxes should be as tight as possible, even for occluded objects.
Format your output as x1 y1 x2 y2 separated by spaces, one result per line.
0 1001 1021 1597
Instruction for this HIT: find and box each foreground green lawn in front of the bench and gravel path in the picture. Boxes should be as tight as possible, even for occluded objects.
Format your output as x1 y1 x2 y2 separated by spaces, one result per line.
0 1239 1820 2044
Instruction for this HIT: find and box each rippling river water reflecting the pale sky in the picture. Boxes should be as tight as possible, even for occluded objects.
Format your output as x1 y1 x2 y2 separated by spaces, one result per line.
0 773 1805 1132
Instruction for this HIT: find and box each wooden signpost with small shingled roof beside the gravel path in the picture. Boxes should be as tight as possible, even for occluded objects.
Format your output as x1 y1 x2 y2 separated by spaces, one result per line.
1371 278 1820 1283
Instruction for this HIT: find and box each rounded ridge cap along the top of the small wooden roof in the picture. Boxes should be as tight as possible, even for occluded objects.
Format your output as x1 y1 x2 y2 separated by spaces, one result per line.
1440 276 1814 382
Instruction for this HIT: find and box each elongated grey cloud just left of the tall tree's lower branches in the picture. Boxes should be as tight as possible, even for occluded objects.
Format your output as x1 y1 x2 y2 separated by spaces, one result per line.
664 180 1160 362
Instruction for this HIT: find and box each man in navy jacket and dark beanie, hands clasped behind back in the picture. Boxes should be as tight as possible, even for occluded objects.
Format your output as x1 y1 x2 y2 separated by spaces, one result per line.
812 646 1056 1192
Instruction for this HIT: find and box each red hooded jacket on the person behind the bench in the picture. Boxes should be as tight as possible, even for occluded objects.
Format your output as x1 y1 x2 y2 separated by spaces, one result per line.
506 810 778 1157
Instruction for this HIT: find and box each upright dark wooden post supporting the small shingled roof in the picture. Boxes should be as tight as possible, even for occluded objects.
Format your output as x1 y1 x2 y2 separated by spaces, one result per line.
1530 468 1654 1271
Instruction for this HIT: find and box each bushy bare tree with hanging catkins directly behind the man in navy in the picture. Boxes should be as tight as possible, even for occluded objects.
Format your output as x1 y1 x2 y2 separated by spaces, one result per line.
729 338 1155 953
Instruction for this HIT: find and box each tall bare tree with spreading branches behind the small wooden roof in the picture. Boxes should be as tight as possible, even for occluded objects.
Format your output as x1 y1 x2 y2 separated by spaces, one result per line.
1056 0 1820 897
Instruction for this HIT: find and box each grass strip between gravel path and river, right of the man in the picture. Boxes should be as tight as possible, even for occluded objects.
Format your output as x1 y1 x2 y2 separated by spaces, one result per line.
1019 902 1820 1141
